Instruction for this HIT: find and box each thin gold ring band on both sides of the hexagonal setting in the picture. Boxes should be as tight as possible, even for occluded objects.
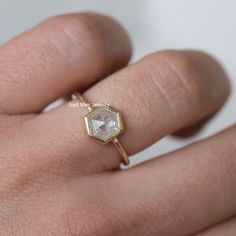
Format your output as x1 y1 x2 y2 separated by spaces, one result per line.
74 92 129 165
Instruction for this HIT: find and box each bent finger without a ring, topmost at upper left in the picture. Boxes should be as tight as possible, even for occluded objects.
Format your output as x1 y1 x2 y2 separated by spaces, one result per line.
0 13 131 114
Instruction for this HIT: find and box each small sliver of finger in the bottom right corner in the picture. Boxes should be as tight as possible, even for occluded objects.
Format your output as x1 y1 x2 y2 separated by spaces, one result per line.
194 217 236 236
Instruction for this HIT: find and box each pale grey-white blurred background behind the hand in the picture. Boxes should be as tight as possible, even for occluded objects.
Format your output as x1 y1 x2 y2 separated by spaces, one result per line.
0 0 236 163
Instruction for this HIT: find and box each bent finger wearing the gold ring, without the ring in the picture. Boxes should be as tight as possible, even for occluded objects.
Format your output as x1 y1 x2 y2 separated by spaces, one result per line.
6 51 229 176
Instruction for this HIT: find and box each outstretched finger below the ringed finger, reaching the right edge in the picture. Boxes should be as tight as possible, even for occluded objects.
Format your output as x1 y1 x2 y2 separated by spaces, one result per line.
104 126 236 236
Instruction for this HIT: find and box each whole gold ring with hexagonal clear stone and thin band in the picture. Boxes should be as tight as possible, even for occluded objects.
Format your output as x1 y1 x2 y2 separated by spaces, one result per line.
74 92 129 165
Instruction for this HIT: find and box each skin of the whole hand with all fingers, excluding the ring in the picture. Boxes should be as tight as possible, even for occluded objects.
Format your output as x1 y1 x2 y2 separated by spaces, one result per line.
0 13 236 236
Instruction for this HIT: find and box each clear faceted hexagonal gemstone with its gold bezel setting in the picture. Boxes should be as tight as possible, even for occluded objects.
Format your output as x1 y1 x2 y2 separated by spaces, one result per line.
85 107 123 142
